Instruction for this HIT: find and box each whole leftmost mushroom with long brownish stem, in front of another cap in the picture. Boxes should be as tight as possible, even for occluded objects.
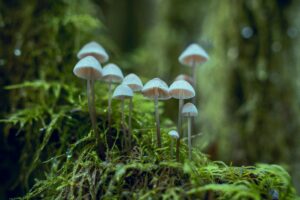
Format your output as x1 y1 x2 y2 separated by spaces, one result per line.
73 56 102 143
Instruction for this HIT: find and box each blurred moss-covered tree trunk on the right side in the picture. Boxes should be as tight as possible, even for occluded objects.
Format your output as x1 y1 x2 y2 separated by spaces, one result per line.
200 0 300 189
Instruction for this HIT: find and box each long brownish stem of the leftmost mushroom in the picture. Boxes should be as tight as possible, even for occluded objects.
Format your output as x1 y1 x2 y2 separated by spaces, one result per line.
87 80 99 144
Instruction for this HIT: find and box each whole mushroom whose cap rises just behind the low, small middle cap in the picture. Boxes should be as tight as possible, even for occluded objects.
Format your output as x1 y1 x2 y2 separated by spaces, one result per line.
122 73 143 138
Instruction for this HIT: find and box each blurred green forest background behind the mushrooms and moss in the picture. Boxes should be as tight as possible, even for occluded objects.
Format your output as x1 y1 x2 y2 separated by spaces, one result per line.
0 0 300 199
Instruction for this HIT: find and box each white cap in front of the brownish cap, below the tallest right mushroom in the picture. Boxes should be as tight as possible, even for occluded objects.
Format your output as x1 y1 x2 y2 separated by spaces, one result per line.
169 80 195 99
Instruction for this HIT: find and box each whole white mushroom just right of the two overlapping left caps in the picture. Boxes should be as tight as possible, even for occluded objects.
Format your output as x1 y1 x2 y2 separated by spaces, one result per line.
102 63 124 127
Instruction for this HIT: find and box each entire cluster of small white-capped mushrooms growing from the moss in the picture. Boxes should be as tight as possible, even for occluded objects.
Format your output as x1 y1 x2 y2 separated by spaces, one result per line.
73 41 209 161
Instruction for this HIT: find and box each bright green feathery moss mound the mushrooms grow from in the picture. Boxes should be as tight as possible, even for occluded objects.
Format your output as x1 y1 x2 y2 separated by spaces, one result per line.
4 81 297 199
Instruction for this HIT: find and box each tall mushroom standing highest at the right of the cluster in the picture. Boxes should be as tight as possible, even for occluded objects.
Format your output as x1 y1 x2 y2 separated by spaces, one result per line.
178 43 209 104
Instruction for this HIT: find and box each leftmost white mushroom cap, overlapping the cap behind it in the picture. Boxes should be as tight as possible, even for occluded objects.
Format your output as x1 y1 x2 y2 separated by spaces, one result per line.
73 56 102 80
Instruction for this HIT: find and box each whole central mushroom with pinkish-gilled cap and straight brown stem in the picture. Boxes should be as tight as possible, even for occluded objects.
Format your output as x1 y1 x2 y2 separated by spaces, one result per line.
142 78 170 148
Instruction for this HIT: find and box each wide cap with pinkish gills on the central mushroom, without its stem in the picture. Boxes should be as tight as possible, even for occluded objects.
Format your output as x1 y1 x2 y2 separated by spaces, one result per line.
142 78 170 100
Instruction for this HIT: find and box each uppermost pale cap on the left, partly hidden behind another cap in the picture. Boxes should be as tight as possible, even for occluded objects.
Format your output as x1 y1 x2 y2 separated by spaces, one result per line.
77 41 109 63
